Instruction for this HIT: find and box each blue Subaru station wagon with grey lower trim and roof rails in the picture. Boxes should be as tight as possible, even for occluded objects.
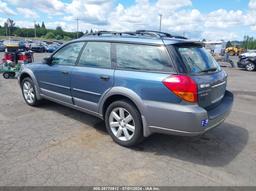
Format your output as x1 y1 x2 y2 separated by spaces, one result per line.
19 30 233 147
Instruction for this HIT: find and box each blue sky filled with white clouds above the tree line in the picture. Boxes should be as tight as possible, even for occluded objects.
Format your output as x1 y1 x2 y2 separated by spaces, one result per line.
0 0 256 40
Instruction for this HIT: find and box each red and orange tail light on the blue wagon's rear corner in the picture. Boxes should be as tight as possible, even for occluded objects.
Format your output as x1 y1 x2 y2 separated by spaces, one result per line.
163 75 197 103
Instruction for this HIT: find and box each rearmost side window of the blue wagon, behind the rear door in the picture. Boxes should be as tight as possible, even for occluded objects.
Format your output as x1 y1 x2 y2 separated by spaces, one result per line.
116 44 173 72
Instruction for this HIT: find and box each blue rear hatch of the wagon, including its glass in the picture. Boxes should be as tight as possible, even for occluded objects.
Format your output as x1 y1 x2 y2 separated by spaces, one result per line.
175 43 227 110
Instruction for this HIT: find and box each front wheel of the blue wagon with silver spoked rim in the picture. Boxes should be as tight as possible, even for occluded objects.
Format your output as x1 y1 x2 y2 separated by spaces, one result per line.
21 78 39 106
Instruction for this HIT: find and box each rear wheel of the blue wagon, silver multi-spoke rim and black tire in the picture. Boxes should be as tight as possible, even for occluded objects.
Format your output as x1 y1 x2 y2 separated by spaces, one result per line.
105 100 143 147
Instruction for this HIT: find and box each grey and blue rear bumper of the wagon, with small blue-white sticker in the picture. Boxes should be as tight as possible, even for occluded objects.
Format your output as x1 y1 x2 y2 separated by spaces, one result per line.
145 91 234 136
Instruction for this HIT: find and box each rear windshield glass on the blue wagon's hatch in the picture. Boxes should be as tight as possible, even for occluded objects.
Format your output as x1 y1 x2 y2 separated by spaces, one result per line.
177 46 221 74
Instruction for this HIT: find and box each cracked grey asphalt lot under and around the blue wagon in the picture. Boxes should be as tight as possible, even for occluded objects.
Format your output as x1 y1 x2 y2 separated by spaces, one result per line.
0 55 256 186
